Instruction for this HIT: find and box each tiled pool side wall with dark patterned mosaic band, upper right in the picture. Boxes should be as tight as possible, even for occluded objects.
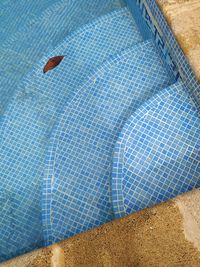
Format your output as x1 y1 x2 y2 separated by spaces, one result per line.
133 0 200 106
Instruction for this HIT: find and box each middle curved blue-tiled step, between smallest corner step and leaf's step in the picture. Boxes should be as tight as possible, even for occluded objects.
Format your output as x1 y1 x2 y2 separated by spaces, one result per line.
42 41 174 244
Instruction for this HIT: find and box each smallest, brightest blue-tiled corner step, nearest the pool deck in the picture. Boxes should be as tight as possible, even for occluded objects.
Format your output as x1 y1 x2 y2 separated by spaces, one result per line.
112 82 200 217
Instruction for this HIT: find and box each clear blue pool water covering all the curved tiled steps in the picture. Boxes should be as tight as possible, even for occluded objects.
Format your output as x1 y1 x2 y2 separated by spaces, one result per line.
0 0 200 261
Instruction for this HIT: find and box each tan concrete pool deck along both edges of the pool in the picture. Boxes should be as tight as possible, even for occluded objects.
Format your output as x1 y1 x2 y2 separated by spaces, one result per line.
0 0 200 267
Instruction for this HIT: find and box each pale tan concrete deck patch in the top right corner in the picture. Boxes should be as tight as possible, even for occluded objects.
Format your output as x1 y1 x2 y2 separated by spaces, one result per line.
156 0 200 81
